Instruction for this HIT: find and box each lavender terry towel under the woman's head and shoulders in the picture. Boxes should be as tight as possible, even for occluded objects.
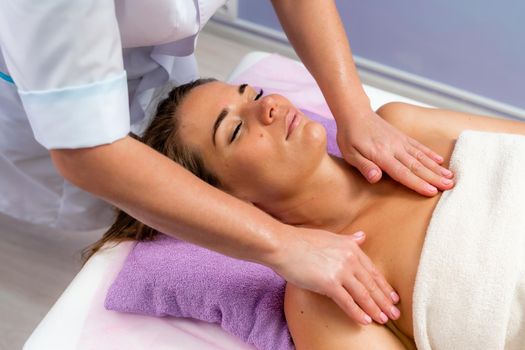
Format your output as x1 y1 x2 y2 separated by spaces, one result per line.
105 111 340 350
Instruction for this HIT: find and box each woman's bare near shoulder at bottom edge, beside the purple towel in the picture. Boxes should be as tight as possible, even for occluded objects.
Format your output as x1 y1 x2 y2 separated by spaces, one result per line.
284 284 405 350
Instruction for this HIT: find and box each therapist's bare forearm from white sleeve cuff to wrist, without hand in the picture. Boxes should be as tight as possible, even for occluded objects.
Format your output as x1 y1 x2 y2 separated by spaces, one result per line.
51 137 286 266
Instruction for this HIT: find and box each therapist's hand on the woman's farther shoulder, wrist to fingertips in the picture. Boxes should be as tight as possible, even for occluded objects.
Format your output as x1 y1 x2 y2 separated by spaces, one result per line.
337 110 454 197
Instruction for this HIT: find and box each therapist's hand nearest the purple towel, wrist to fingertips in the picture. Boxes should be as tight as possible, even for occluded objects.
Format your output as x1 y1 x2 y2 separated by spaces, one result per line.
274 227 399 325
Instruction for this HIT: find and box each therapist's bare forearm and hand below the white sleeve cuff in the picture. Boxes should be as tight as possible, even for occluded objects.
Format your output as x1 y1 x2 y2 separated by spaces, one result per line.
51 137 397 324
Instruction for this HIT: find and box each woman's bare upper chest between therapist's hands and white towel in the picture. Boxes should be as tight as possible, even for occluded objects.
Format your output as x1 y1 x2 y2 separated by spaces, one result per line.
347 193 440 339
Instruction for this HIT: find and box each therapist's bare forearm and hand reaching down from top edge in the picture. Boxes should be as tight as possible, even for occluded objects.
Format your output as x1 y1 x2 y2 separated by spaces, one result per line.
272 0 453 196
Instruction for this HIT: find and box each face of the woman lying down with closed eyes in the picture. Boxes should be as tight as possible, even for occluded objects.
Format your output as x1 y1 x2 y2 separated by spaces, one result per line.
177 82 326 204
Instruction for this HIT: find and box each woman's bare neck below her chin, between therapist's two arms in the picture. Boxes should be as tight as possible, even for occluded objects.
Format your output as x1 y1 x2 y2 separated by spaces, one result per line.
261 155 379 232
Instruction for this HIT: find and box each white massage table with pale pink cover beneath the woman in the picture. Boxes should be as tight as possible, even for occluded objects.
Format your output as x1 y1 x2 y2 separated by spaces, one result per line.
24 52 423 350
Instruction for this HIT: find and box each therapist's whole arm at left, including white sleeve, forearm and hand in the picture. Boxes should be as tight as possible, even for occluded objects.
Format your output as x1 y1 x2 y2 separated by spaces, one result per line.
0 0 392 323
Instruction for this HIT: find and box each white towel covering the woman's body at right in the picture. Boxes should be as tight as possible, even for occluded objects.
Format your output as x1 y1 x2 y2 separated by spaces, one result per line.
413 131 525 350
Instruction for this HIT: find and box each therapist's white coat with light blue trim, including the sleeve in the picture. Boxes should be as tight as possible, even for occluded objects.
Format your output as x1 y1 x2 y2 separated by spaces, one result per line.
0 0 225 231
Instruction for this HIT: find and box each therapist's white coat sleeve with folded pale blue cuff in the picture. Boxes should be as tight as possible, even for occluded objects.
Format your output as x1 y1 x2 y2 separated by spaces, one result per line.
0 0 129 149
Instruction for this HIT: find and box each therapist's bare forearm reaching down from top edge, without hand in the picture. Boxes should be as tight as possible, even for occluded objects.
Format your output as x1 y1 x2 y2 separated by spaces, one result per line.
272 0 371 122
